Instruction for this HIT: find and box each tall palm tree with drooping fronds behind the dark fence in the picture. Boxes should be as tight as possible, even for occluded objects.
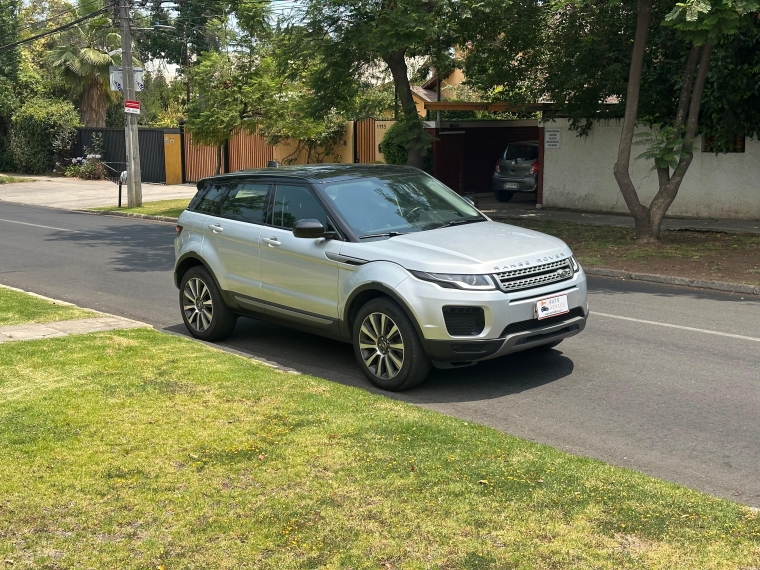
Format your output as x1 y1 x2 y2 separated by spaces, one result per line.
48 0 121 127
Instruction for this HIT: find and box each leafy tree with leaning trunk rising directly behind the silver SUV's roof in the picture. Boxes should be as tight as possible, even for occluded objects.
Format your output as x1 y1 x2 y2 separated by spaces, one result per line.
304 0 454 168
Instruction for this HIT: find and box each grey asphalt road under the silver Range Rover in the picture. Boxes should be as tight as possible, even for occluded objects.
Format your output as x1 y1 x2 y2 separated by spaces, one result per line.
0 202 760 507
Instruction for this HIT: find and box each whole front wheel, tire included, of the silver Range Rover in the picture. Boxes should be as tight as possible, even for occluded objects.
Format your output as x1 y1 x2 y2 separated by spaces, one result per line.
353 297 431 392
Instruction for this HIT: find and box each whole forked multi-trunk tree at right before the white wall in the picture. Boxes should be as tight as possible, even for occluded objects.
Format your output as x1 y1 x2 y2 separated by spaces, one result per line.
613 0 758 243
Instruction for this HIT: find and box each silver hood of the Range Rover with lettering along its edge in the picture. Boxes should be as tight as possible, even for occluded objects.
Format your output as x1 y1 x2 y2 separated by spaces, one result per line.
341 221 572 274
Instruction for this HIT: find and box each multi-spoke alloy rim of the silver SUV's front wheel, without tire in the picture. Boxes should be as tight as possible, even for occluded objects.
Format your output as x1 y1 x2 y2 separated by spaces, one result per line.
359 313 404 380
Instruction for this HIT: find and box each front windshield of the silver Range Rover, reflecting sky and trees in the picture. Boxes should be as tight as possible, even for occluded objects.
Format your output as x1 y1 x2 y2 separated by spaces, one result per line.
322 173 485 238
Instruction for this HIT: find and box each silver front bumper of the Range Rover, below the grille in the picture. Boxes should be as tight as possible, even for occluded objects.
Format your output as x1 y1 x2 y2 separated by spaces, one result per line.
397 269 588 362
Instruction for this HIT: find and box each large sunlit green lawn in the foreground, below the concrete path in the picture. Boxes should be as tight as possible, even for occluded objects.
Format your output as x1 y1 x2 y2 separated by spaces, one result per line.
0 322 760 570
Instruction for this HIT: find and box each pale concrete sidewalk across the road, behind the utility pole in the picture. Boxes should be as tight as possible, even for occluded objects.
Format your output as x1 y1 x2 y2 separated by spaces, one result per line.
0 176 196 210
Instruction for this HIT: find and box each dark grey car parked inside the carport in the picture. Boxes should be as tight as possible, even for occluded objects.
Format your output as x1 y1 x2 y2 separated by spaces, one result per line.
491 141 538 202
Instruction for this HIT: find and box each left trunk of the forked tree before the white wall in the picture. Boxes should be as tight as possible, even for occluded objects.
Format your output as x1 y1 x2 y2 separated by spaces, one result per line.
613 0 657 241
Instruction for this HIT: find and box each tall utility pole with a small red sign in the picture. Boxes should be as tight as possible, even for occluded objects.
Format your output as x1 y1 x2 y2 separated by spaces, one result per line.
119 0 142 208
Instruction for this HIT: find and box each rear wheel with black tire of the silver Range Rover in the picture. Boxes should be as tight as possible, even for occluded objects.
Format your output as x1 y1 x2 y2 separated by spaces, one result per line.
179 266 237 342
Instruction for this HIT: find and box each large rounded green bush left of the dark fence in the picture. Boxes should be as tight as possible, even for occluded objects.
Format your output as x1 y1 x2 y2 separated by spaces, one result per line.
10 99 79 174
